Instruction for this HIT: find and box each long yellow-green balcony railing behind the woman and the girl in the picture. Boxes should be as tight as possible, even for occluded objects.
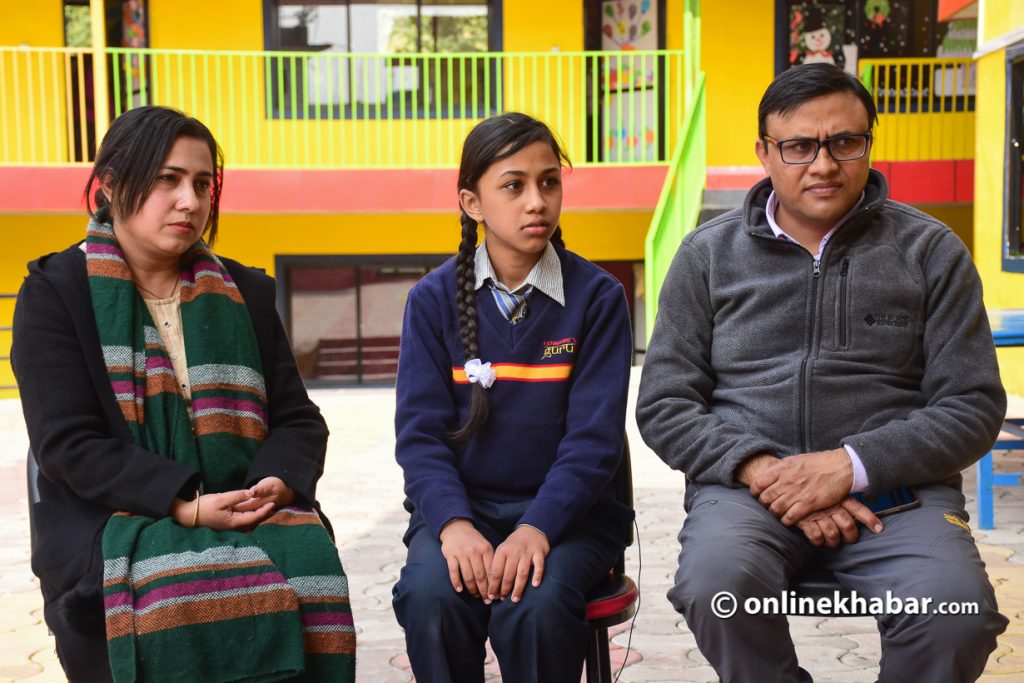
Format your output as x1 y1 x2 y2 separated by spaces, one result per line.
0 47 690 168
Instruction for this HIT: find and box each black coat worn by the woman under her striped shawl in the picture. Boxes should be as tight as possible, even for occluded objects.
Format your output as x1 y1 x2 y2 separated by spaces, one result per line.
11 245 328 640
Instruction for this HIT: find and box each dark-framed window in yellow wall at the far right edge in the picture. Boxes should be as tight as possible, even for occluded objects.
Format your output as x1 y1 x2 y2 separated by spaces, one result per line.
1002 45 1024 272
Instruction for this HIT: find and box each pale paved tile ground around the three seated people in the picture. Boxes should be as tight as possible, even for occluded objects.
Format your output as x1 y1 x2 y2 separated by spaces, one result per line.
0 374 1024 683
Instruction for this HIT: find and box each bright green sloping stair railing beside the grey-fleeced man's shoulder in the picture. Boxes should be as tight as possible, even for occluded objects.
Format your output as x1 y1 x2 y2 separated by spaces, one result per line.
644 73 708 339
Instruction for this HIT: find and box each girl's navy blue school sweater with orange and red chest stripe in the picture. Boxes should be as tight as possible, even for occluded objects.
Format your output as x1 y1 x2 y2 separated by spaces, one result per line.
395 249 633 543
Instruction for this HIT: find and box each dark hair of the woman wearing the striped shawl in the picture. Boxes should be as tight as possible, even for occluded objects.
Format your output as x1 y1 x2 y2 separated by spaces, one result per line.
85 106 224 245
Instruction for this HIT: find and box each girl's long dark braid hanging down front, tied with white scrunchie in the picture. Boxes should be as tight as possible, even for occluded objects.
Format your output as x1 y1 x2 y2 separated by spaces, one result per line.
452 211 490 442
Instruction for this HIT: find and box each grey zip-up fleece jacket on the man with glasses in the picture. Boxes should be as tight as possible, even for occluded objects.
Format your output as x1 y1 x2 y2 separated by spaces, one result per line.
637 170 1006 493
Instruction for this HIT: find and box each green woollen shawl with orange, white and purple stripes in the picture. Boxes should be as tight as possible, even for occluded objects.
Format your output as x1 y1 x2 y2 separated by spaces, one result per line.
92 219 355 683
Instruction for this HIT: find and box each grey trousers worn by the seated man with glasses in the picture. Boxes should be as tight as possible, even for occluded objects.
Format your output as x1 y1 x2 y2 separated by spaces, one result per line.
669 483 1009 683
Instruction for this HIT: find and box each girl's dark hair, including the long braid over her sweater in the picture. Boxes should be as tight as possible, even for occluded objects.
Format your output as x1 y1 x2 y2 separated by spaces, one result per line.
452 112 572 442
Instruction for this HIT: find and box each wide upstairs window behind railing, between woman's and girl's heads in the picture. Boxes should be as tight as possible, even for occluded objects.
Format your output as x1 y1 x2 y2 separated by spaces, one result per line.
264 0 501 119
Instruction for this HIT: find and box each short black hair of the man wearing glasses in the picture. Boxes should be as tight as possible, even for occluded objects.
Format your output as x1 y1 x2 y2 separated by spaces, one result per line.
758 63 879 144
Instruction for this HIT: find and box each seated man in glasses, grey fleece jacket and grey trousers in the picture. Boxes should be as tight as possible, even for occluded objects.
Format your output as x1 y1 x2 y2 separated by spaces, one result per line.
637 65 1008 683
